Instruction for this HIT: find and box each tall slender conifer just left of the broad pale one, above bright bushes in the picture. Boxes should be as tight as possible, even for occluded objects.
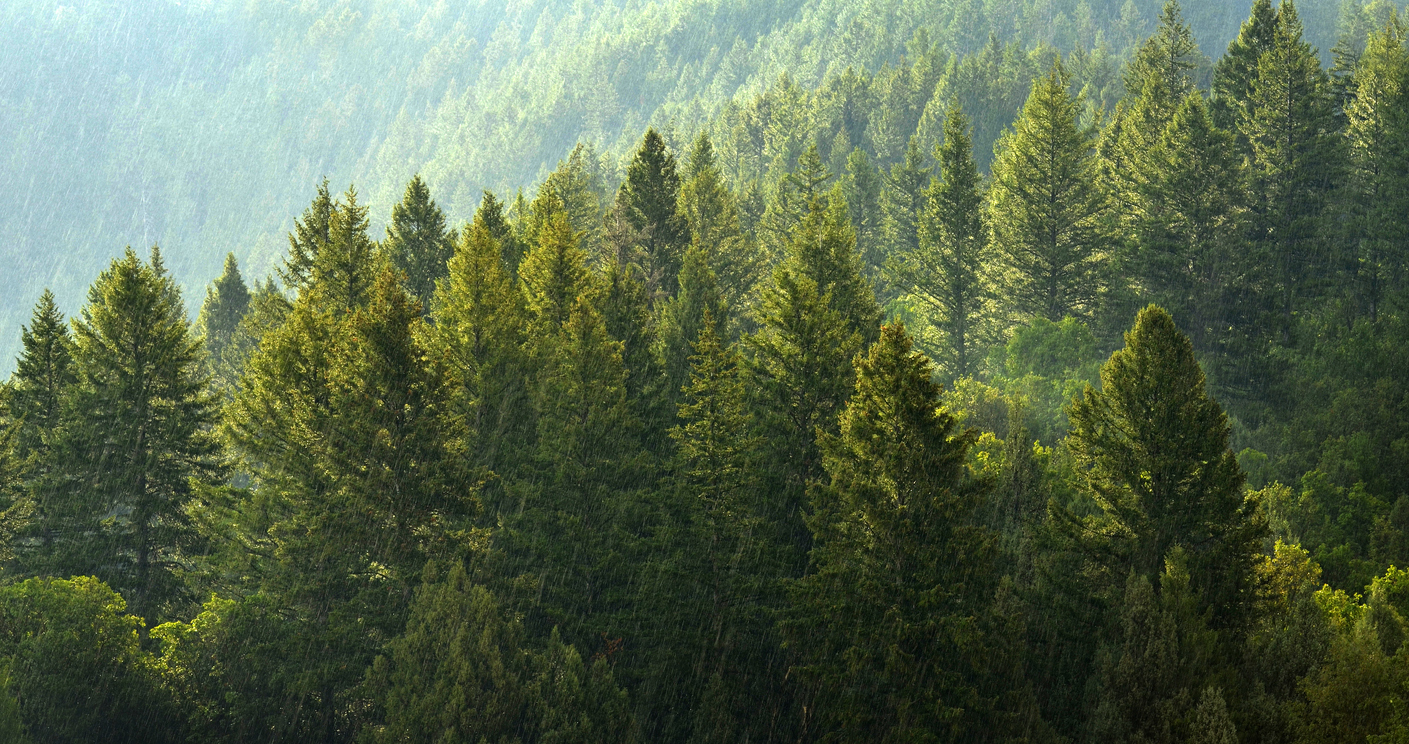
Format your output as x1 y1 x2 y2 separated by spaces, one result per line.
890 106 992 378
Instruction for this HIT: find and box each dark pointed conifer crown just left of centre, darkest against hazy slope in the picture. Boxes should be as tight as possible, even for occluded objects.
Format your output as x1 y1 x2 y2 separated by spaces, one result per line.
617 128 689 297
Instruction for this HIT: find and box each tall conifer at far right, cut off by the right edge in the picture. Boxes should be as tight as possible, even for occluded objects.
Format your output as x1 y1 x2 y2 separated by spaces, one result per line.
1346 17 1409 320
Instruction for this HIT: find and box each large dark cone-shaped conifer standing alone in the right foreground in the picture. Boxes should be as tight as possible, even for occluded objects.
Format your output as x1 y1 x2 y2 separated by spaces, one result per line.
1068 306 1265 633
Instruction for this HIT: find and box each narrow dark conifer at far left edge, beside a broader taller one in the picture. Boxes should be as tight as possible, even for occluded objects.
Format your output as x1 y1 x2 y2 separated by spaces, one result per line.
3 290 75 459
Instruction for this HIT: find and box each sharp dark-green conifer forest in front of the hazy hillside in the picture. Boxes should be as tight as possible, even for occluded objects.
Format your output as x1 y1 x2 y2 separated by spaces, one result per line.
0 0 1409 744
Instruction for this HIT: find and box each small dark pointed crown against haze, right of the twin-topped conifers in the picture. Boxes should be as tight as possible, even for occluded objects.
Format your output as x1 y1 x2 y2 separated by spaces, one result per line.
385 173 455 314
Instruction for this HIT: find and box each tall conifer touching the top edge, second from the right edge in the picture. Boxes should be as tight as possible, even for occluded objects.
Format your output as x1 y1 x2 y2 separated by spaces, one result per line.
1239 1 1340 333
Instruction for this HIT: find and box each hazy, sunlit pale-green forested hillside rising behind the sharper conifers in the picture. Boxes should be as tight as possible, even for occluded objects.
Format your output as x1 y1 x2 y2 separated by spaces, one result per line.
0 0 1339 364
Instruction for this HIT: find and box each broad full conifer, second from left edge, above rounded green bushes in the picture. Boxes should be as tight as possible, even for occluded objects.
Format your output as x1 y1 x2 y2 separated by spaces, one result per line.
34 248 224 621
